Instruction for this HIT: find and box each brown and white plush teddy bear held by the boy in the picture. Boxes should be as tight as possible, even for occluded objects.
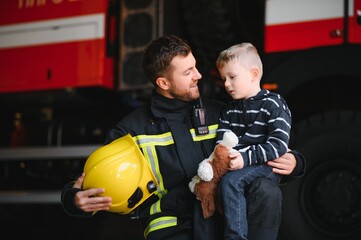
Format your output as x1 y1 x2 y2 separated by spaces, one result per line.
189 131 238 218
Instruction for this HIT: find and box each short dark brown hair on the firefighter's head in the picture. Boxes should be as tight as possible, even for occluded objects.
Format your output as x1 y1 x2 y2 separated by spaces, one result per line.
143 35 192 86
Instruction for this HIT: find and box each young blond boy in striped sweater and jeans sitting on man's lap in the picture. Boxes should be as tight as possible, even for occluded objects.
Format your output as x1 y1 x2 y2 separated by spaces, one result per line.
216 43 291 239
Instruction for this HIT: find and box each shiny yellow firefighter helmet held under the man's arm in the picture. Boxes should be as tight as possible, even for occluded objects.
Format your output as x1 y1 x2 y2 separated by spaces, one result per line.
83 134 158 214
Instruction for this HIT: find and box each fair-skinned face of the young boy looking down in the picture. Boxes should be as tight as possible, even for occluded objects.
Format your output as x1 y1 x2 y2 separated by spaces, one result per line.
218 60 260 99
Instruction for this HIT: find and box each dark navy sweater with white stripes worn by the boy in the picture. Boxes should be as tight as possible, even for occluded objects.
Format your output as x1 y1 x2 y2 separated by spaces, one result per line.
217 90 291 166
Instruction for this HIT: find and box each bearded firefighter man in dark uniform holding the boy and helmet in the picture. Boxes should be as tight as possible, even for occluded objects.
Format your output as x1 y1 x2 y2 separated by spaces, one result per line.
61 36 305 240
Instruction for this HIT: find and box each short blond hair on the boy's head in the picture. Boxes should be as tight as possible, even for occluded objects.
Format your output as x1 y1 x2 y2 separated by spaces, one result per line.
216 42 263 76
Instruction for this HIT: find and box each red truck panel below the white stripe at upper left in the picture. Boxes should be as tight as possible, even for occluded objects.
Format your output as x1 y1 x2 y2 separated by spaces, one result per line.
0 40 113 92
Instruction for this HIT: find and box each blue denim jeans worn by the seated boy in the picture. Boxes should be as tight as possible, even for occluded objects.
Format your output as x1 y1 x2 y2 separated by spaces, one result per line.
219 164 281 240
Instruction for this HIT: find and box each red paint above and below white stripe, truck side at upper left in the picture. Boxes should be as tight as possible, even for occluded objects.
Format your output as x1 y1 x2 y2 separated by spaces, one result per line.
0 0 114 93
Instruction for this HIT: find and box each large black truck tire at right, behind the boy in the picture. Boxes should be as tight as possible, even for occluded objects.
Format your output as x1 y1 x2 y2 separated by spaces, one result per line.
279 111 361 240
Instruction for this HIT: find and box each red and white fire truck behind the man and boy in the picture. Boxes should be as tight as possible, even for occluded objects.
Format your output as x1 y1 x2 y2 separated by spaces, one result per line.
0 0 361 240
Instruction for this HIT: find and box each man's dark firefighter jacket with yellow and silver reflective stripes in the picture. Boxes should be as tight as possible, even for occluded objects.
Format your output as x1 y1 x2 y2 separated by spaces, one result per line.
106 92 224 239
